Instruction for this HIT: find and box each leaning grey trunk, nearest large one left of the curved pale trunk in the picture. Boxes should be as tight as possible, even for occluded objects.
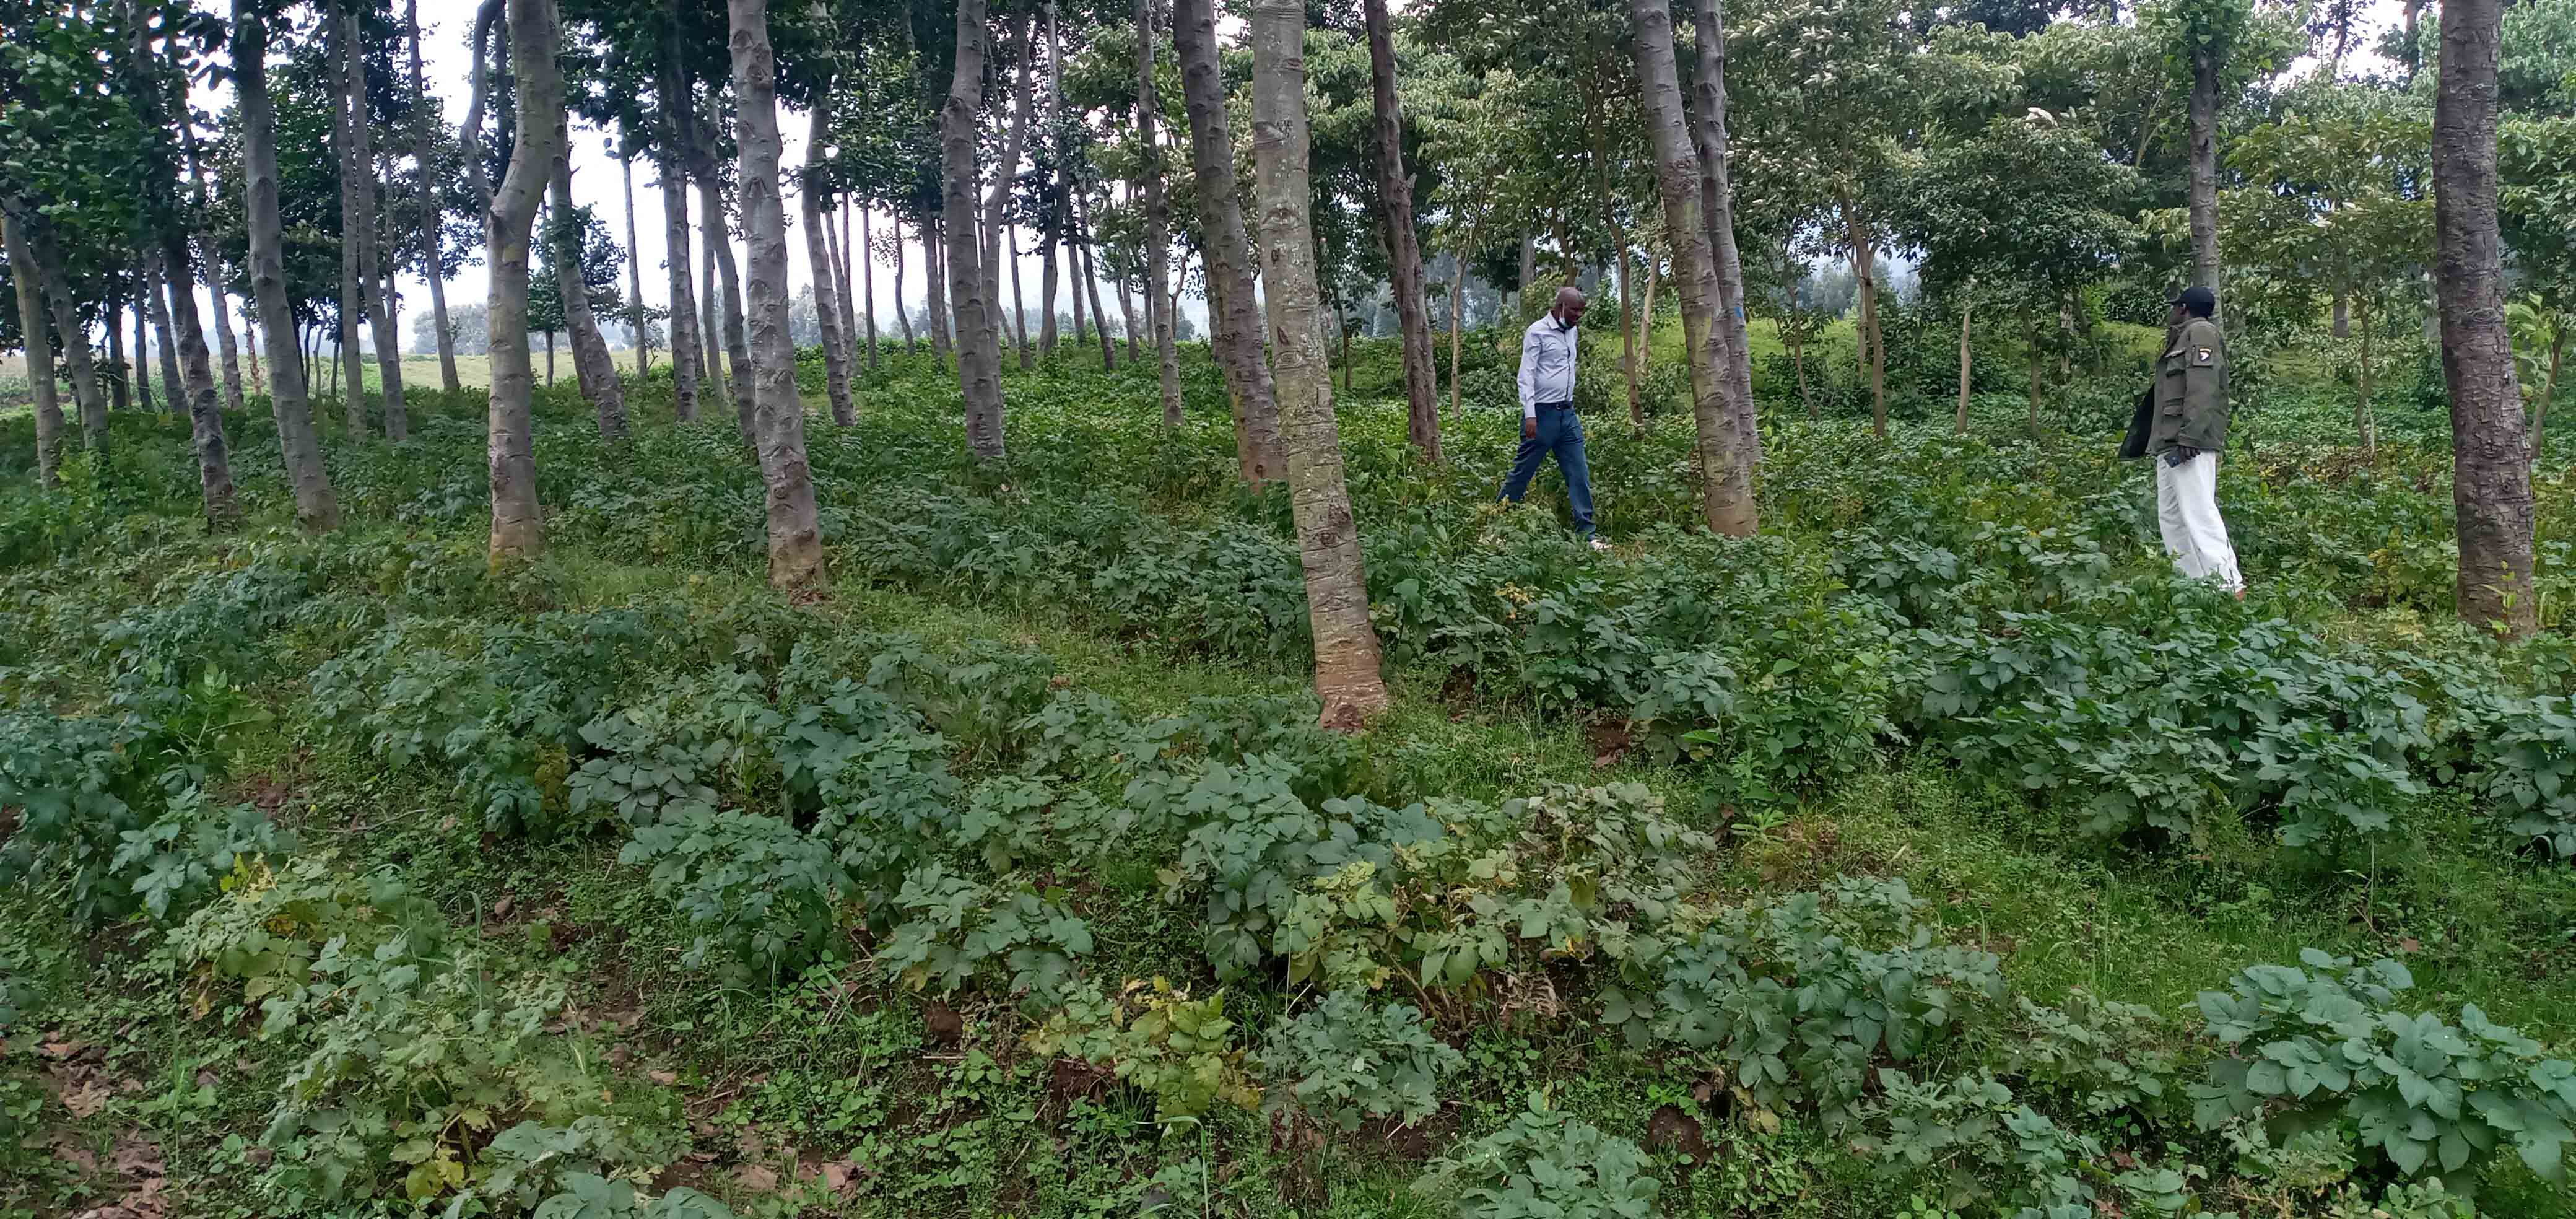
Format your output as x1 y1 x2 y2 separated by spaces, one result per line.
232 0 340 533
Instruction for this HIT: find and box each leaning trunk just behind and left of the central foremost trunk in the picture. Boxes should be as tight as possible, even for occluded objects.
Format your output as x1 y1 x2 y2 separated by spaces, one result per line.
1172 0 1282 487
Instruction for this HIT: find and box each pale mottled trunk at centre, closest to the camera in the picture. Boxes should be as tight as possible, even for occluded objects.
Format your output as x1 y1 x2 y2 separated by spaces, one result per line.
1252 0 1386 732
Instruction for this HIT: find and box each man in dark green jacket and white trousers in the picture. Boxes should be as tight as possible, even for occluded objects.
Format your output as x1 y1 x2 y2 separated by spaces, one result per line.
2120 289 2247 600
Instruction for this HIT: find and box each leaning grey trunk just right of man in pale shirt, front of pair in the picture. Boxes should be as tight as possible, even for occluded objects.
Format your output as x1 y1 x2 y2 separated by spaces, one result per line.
1630 0 1762 539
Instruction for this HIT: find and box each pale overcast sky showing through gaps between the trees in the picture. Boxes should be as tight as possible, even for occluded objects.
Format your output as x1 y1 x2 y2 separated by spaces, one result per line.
171 0 2401 348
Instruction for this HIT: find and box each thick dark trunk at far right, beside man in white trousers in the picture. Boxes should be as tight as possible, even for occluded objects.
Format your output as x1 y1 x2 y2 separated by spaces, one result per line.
2432 0 2540 637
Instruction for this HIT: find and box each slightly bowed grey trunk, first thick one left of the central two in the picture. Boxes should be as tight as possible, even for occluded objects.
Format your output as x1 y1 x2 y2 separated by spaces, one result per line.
940 0 1007 461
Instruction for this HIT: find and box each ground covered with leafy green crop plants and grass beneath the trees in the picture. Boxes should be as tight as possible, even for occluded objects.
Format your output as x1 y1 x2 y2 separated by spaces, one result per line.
0 343 2576 1219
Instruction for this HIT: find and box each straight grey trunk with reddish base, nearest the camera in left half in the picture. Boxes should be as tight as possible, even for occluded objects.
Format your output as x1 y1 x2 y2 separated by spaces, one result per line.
726 0 824 588
